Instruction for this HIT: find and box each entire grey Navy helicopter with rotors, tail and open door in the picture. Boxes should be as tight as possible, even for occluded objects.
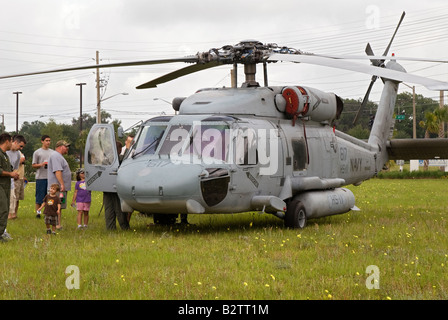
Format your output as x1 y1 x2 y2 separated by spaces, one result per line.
0 13 448 228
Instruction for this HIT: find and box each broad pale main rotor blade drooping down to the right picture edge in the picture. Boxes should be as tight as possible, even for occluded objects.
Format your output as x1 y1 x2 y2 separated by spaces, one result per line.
268 53 448 91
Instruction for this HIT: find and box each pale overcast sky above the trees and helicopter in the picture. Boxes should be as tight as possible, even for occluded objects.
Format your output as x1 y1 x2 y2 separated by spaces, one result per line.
0 0 448 131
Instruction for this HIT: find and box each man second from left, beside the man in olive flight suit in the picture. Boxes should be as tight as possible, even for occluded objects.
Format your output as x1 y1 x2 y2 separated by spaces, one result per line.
6 135 26 219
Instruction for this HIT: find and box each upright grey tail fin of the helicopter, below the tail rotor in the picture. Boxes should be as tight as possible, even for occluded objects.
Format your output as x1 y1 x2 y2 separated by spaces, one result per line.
368 61 406 170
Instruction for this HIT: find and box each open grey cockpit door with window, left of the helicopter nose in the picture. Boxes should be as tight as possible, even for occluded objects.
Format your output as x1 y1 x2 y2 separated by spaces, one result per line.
84 124 120 192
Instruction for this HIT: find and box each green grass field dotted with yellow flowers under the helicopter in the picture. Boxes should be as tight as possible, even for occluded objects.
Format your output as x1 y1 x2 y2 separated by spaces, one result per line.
0 179 448 300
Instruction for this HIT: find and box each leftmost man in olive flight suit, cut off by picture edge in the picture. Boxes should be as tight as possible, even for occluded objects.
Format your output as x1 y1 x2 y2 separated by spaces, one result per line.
0 133 19 242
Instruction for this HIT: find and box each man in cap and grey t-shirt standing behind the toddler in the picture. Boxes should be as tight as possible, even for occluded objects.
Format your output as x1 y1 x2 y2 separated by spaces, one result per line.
48 140 72 229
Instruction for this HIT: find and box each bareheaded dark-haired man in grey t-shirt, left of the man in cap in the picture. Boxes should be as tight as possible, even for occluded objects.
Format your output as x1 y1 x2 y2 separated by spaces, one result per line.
32 135 54 218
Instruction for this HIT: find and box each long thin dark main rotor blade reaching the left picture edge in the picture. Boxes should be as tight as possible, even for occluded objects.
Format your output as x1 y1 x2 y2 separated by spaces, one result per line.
0 56 198 79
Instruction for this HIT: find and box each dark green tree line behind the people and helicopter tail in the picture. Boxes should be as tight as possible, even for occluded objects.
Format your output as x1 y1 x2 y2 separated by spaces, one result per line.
4 92 448 181
